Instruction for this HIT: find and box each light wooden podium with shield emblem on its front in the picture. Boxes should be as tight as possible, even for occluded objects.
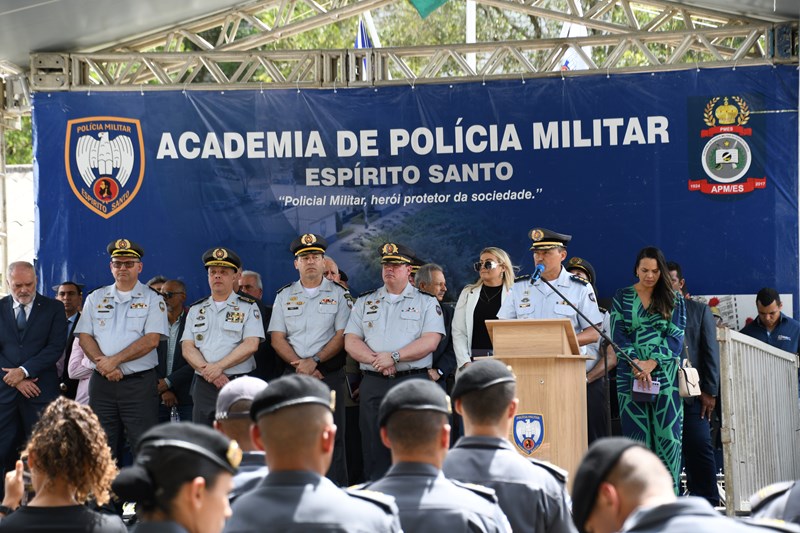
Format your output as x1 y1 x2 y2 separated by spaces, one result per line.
486 318 587 476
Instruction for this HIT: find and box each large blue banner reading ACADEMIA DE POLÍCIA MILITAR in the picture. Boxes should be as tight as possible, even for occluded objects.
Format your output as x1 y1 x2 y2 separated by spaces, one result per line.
33 66 798 303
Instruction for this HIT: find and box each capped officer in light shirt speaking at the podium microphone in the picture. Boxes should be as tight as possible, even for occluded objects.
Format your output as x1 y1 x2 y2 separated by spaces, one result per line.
497 228 603 346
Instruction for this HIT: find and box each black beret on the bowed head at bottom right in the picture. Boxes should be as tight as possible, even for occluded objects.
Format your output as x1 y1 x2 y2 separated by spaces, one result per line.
572 437 643 533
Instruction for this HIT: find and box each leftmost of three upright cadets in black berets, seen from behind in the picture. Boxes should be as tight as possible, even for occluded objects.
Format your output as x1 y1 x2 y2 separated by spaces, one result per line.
225 374 400 533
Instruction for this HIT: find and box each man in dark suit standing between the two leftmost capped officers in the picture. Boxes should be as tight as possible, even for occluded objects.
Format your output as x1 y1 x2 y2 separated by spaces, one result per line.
156 279 194 422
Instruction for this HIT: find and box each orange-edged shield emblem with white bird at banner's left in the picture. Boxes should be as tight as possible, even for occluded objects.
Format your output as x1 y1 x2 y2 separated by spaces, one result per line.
64 116 145 219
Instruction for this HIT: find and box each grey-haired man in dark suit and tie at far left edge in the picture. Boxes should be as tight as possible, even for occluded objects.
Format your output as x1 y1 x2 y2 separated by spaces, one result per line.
0 261 67 486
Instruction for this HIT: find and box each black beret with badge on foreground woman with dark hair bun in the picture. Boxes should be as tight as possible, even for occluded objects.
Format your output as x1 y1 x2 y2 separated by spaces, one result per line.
136 422 242 474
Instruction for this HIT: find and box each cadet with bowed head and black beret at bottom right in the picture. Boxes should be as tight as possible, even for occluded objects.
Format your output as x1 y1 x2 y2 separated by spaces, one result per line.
572 437 798 533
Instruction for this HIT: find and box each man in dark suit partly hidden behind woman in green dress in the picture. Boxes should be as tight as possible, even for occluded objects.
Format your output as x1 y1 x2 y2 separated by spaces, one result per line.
667 261 719 506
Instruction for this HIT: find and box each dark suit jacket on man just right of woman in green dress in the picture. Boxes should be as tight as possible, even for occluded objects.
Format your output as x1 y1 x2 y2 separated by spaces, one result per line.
684 299 719 396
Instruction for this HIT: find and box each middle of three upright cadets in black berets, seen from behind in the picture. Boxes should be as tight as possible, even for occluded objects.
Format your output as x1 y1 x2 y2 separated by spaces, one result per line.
364 379 511 533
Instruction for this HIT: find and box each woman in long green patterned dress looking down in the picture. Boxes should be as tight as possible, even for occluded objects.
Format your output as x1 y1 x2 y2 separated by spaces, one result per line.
611 247 686 493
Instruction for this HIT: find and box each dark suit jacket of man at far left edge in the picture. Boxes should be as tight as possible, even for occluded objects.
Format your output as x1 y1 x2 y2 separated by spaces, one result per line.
0 293 67 403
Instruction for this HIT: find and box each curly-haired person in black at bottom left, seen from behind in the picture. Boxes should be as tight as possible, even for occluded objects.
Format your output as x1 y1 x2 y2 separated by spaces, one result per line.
0 397 127 533
